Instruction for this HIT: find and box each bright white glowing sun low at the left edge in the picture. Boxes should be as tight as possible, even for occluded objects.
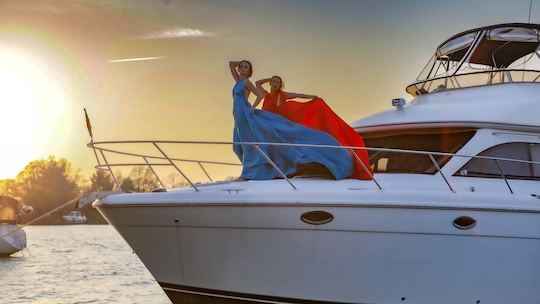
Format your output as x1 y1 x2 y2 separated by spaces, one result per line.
0 49 65 179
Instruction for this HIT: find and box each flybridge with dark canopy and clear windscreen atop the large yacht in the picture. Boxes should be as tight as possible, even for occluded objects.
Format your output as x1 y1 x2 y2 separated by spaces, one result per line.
406 23 540 96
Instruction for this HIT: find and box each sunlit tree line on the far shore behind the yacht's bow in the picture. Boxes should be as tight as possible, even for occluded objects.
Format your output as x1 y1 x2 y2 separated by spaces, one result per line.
0 156 186 224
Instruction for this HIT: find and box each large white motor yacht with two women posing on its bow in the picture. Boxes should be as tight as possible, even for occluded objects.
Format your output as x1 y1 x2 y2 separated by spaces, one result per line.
92 23 540 304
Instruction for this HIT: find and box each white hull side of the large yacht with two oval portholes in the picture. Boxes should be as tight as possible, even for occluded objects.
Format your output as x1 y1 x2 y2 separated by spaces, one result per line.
95 196 540 304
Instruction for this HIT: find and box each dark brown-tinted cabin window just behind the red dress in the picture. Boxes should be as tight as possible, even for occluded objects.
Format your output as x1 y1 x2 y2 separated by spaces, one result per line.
361 128 476 174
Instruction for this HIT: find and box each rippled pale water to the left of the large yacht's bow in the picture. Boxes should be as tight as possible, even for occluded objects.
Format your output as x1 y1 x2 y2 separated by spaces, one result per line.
0 225 170 304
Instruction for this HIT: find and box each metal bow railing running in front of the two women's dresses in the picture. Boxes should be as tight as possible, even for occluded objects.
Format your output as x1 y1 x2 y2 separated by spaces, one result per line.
87 140 540 194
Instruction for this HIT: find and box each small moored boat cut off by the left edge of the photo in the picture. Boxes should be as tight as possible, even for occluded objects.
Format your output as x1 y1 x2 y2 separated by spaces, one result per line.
0 196 32 257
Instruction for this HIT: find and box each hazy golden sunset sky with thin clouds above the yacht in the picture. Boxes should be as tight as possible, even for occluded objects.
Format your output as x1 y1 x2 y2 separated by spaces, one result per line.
0 0 540 179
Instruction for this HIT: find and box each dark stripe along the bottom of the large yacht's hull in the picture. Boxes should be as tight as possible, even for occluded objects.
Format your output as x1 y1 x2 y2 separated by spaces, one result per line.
159 282 368 304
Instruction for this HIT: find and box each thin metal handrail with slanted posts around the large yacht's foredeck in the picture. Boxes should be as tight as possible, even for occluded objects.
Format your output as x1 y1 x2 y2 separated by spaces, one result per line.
87 140 540 194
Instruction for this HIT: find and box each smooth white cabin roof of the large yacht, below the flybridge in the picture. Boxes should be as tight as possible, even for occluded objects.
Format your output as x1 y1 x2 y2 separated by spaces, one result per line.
351 83 540 132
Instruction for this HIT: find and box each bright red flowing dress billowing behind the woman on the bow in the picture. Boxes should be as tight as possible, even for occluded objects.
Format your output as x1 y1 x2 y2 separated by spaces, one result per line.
262 91 373 179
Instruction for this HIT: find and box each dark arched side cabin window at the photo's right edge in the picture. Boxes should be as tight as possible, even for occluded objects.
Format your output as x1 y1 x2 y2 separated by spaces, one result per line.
454 142 540 179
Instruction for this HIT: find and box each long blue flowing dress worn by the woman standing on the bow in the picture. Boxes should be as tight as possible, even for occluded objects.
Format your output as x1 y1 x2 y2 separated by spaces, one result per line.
233 79 353 180
